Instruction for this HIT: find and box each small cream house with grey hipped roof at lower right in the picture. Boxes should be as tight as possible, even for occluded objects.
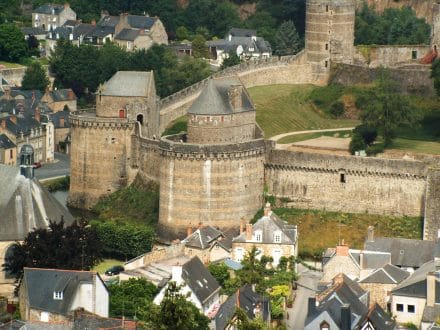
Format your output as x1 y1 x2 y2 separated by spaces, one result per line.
359 264 410 310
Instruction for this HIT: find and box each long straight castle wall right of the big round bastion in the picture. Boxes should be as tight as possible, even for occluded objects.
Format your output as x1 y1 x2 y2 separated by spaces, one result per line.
265 150 428 216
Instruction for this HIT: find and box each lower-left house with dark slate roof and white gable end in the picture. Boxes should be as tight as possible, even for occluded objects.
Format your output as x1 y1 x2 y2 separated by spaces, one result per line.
19 267 109 322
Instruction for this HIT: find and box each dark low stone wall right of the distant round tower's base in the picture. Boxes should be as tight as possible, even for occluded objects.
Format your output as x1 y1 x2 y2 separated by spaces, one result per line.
329 63 435 97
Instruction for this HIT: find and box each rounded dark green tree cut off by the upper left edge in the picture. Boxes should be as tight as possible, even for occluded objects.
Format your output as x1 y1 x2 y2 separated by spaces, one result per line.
0 23 27 62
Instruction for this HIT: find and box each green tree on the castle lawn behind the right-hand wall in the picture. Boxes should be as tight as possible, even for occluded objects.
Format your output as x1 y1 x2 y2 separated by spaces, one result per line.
360 70 422 146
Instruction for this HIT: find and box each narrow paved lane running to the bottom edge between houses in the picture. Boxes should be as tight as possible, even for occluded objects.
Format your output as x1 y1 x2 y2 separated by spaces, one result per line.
287 264 322 330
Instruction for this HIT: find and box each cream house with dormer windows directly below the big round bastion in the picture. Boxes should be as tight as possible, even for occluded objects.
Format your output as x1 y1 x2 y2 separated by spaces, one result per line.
232 203 298 267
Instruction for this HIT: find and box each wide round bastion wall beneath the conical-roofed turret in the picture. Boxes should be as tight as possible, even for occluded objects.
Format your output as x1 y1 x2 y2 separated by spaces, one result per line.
159 135 265 237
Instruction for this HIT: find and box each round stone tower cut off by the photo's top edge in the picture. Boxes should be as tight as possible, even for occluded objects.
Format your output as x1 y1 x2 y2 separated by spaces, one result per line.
305 0 355 69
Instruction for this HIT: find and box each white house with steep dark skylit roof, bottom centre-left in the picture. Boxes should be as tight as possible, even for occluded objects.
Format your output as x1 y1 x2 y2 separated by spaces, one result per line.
153 257 221 315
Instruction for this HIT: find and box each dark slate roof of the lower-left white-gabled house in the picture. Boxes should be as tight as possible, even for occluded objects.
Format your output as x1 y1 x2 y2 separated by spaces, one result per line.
23 267 104 315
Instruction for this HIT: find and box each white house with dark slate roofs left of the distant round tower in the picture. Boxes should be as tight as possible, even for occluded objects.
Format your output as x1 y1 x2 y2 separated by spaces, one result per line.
206 28 272 65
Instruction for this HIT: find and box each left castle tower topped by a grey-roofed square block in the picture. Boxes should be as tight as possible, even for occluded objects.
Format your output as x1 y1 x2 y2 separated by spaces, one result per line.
68 71 159 208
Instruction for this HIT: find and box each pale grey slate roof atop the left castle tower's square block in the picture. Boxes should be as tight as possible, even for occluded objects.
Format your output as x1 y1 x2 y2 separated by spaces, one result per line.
101 71 154 97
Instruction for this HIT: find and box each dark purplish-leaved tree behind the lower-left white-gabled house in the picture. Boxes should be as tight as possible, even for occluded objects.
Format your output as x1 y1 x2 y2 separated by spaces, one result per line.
3 221 102 279
